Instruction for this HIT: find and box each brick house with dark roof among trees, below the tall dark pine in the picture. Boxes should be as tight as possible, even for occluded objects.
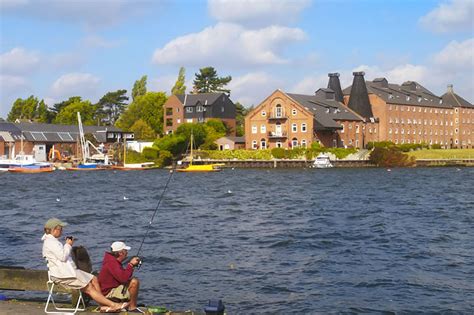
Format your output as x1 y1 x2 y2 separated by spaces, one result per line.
163 93 236 135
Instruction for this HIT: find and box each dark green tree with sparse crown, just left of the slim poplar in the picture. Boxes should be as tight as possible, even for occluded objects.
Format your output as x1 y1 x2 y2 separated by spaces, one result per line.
95 90 128 125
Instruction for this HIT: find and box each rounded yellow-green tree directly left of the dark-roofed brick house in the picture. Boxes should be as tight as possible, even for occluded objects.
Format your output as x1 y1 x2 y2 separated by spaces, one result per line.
116 92 167 135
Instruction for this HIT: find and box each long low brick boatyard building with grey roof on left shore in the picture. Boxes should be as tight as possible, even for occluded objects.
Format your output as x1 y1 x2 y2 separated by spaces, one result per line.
0 122 134 162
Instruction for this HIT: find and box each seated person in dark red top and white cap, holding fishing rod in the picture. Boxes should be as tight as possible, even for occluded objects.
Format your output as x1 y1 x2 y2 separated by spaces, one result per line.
99 242 142 313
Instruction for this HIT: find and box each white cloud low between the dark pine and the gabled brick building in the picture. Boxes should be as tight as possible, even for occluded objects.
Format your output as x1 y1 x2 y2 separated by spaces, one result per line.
228 72 283 107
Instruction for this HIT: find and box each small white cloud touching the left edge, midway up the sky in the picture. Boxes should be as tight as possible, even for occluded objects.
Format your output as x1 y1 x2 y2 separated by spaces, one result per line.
0 47 40 75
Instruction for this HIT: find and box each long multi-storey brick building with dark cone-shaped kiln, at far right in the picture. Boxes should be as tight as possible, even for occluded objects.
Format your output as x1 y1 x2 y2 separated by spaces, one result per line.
343 72 474 148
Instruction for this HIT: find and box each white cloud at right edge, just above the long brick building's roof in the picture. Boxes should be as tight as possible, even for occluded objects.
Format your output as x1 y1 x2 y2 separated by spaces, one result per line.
433 38 474 71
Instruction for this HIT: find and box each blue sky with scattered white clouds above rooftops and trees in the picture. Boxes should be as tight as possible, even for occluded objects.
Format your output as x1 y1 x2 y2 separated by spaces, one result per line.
0 0 474 118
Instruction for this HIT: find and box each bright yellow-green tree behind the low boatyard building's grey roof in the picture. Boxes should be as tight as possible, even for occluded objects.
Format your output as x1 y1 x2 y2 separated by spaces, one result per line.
54 97 95 125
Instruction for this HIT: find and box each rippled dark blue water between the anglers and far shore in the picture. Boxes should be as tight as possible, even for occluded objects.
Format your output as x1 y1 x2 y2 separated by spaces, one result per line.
0 168 474 314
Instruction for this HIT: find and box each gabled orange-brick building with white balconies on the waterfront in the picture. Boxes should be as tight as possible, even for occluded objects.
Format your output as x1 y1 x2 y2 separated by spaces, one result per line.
245 73 365 149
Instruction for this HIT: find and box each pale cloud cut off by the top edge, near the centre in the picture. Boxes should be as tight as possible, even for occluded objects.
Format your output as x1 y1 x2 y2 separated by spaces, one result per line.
208 0 311 26
